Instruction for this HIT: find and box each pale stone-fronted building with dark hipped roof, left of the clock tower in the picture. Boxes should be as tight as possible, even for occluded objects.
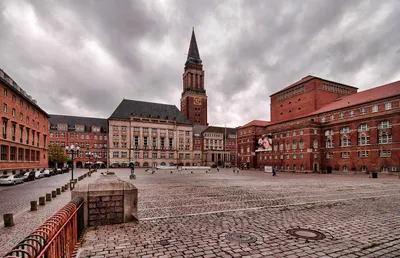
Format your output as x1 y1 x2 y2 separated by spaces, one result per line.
108 99 193 167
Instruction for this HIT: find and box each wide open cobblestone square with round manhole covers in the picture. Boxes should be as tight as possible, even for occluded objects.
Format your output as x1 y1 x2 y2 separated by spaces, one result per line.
78 169 400 258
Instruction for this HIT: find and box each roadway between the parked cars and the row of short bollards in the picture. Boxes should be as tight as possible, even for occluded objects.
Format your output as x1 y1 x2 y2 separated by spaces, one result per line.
0 169 92 224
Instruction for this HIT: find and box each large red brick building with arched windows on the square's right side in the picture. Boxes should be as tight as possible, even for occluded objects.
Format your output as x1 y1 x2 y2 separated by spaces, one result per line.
239 76 400 173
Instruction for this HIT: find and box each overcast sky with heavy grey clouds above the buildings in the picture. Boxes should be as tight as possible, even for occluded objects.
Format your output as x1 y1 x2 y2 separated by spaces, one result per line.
0 0 400 127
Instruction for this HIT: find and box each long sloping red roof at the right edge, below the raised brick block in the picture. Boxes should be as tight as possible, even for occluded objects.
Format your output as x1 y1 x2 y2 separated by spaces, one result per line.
311 81 400 114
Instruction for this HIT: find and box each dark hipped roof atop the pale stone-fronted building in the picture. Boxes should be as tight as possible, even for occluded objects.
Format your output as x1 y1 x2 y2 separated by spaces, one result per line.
110 99 192 125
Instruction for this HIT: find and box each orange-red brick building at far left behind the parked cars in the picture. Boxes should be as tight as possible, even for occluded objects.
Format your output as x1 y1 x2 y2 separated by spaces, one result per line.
0 69 49 174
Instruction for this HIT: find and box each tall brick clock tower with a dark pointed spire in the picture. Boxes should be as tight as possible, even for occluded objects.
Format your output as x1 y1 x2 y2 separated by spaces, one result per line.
181 29 208 125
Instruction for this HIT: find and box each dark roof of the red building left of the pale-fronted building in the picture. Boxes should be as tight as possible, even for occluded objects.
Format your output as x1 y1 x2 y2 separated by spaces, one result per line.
49 114 108 132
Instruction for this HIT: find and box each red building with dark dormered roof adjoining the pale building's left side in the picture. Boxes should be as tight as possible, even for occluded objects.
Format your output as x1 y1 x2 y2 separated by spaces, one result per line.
49 114 108 167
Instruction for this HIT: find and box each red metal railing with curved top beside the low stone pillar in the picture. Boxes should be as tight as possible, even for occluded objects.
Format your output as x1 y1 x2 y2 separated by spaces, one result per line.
4 196 84 258
